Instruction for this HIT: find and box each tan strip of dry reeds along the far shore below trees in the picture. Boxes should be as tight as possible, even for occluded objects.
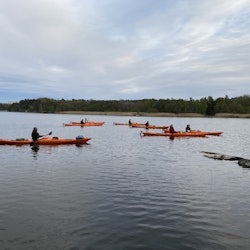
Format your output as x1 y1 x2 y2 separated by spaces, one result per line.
59 111 250 118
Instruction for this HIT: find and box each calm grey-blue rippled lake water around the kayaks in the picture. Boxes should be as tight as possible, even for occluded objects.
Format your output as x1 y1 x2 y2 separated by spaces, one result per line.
0 112 250 250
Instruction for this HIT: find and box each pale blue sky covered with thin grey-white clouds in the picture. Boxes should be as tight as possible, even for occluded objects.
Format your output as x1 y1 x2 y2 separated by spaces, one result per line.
0 0 250 102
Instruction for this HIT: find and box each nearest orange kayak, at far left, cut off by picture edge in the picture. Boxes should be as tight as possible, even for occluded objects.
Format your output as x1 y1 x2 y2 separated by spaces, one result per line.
0 136 91 146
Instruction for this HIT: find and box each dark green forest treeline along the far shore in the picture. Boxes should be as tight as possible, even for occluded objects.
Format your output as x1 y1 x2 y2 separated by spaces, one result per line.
0 95 250 116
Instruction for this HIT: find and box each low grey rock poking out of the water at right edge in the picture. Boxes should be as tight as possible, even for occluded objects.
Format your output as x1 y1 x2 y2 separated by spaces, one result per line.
201 151 250 168
